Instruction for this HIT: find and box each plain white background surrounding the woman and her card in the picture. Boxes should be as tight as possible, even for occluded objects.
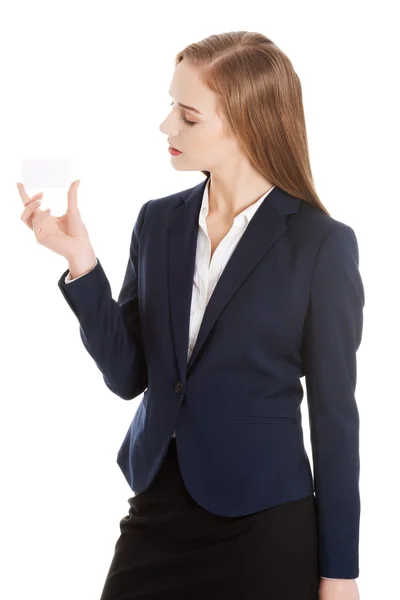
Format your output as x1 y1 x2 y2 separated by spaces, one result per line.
0 0 400 600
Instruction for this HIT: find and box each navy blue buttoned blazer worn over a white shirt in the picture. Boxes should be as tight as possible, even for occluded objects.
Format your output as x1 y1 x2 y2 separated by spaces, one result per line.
58 173 364 579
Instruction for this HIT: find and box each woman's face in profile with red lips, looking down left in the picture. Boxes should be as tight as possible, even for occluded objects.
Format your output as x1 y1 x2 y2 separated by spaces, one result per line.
159 60 240 172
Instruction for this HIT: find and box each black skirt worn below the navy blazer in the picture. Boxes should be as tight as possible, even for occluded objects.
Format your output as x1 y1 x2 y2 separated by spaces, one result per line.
100 438 319 600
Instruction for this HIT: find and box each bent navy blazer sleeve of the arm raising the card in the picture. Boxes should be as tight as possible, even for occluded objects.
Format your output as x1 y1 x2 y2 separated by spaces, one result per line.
58 200 151 400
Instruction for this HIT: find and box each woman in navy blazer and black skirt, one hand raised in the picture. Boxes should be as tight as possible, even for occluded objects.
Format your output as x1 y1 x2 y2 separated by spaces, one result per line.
19 32 364 600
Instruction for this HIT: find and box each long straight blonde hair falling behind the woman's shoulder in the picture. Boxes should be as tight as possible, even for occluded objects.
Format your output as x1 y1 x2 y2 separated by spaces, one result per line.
175 31 329 215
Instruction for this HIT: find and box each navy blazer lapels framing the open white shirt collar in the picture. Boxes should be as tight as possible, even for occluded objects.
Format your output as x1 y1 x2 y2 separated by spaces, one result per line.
169 177 300 379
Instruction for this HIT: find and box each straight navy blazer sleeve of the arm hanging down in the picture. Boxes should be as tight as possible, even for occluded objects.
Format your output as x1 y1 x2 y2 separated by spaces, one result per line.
304 224 365 579
